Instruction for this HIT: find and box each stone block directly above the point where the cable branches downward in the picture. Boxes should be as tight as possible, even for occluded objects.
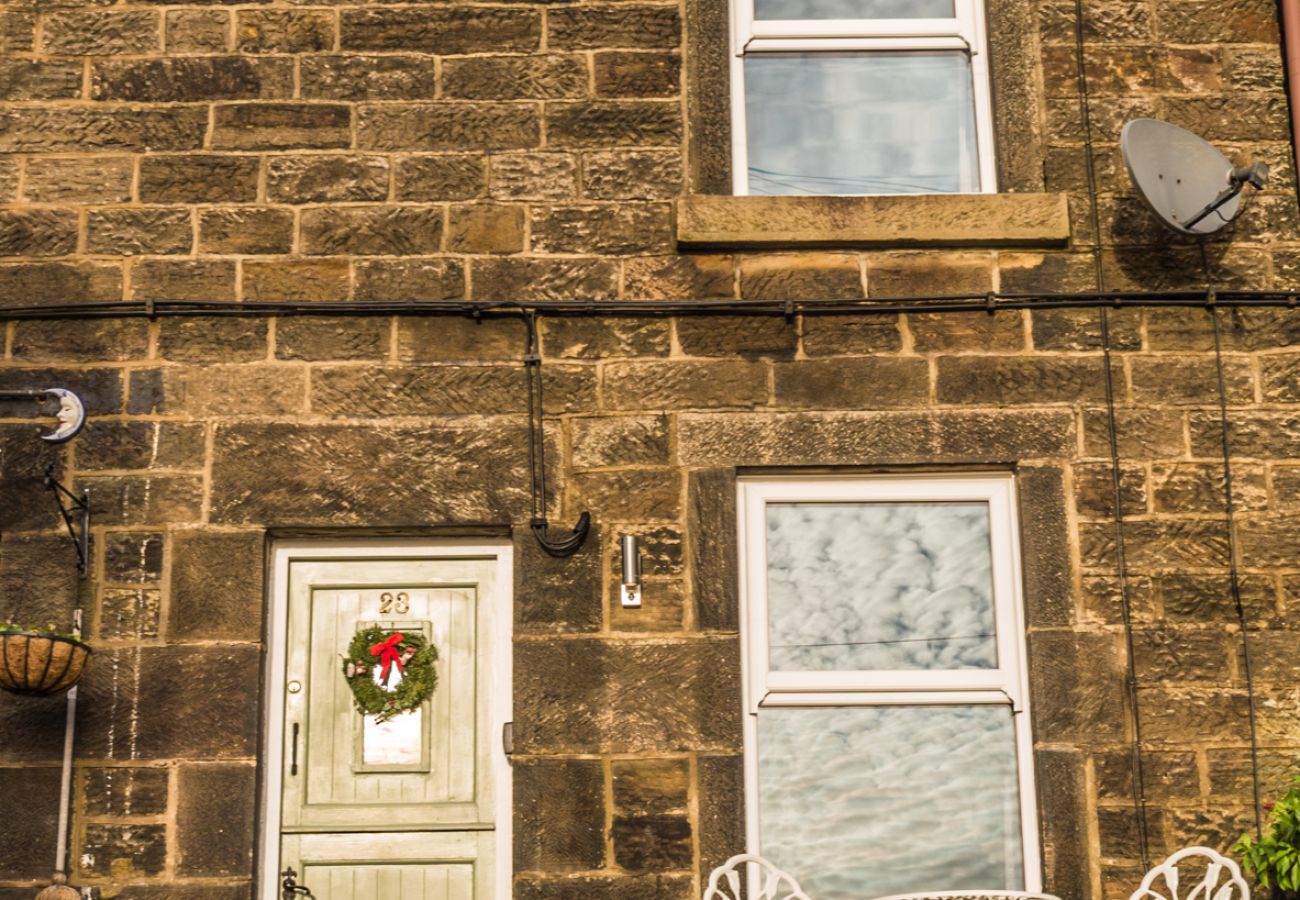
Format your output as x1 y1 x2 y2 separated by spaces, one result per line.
471 258 619 300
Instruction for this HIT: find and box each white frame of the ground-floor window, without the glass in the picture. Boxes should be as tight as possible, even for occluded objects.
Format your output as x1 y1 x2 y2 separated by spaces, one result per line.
736 472 1043 891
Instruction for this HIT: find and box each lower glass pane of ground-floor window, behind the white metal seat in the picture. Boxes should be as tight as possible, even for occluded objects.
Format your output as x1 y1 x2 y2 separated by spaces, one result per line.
758 706 1024 900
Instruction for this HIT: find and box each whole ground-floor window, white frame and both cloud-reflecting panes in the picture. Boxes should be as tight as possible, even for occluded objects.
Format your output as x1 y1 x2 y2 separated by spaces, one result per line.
740 473 1041 900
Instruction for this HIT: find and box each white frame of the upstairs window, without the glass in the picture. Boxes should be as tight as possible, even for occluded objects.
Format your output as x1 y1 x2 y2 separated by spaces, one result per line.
731 0 997 195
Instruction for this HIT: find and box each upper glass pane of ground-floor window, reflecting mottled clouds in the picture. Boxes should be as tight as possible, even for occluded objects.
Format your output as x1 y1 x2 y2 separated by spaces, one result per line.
767 502 997 671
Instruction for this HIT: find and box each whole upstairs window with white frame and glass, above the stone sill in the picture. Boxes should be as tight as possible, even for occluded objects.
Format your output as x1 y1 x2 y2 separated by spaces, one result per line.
732 0 997 194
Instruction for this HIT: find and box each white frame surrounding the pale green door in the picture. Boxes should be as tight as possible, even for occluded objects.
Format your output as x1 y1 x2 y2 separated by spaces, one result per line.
255 538 515 900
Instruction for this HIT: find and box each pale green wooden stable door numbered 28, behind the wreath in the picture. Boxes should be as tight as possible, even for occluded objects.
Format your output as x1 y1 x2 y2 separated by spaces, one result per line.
280 559 499 900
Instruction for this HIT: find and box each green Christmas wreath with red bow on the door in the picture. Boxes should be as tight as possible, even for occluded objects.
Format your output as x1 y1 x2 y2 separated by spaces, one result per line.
343 628 438 722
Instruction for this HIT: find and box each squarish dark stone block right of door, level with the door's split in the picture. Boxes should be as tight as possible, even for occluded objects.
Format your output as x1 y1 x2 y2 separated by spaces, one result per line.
514 760 605 873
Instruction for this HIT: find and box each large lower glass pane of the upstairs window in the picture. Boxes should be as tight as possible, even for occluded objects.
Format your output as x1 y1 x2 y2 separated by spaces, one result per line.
745 51 980 194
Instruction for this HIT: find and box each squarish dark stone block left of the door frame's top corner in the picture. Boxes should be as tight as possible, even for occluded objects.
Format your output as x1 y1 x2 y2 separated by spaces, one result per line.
168 532 264 641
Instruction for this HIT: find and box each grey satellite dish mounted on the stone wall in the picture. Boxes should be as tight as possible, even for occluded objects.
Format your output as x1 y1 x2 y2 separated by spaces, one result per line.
1119 118 1269 235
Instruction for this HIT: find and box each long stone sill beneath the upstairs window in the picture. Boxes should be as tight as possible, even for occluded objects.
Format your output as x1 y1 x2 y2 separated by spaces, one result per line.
676 194 1070 250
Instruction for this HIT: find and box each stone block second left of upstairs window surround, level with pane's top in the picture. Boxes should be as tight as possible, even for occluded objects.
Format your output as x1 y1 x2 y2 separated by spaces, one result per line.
442 53 588 100
